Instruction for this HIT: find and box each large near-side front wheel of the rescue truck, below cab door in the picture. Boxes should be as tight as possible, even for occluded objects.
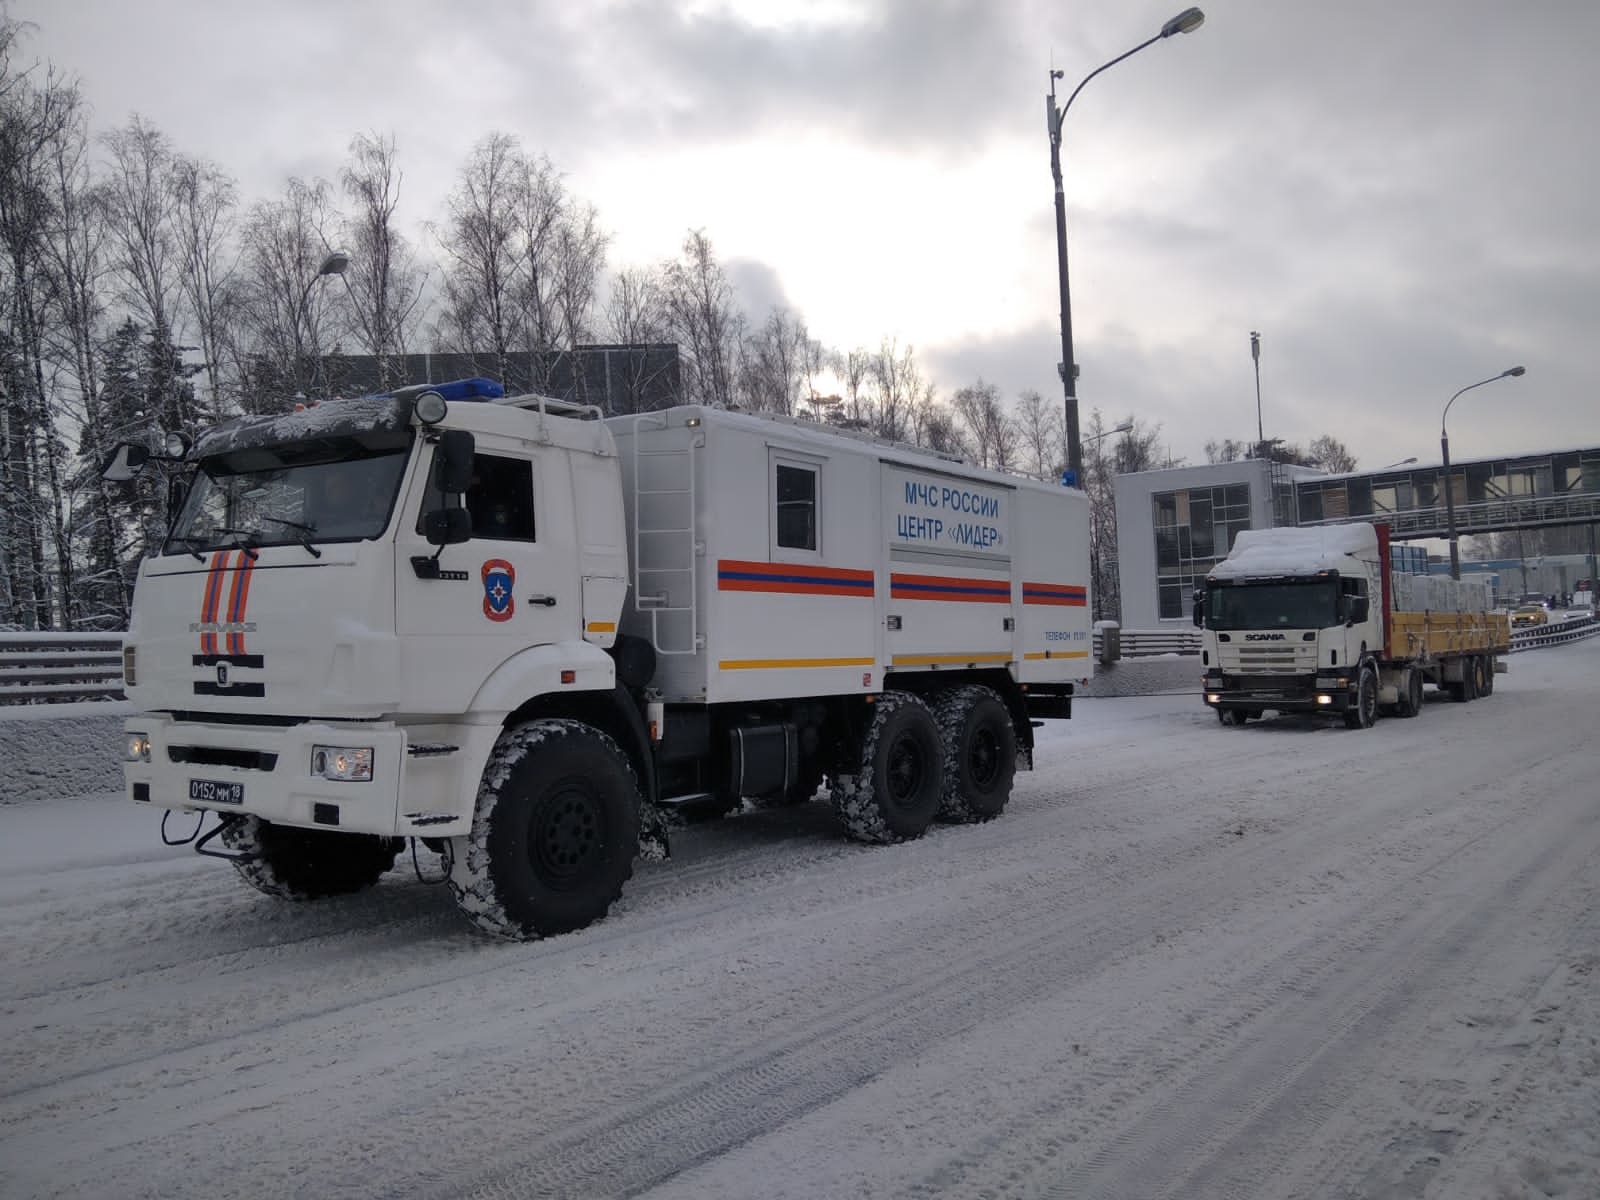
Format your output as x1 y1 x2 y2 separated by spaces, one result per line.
450 718 643 939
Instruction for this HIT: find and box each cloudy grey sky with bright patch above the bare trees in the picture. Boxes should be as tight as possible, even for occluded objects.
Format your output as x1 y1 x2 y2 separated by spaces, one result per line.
8 0 1600 467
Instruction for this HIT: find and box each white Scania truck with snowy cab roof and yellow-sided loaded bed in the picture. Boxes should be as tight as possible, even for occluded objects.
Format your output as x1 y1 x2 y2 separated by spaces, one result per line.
1195 523 1510 730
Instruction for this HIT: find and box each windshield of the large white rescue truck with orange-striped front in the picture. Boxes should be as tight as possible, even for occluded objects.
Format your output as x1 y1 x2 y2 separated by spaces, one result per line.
163 432 411 554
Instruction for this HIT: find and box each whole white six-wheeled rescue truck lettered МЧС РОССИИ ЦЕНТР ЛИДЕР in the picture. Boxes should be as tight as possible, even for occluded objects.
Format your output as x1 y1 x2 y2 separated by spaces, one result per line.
106 381 1091 938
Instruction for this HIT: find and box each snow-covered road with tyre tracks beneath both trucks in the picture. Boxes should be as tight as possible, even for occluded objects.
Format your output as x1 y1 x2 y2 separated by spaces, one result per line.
0 649 1600 1200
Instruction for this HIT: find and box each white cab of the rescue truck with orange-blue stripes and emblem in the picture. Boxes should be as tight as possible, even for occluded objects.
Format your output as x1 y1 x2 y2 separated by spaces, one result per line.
123 386 627 838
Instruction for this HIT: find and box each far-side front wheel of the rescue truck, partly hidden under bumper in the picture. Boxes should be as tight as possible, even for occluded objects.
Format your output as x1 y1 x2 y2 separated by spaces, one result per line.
221 816 405 901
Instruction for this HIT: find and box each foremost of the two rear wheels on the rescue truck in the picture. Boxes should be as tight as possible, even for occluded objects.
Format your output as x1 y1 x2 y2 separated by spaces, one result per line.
830 691 944 845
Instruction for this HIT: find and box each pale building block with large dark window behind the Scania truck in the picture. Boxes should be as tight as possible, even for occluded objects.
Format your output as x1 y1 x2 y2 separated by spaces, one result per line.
1112 459 1325 629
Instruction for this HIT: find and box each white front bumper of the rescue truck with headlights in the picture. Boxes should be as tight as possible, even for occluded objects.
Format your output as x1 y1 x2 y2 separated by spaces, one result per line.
123 714 499 837
